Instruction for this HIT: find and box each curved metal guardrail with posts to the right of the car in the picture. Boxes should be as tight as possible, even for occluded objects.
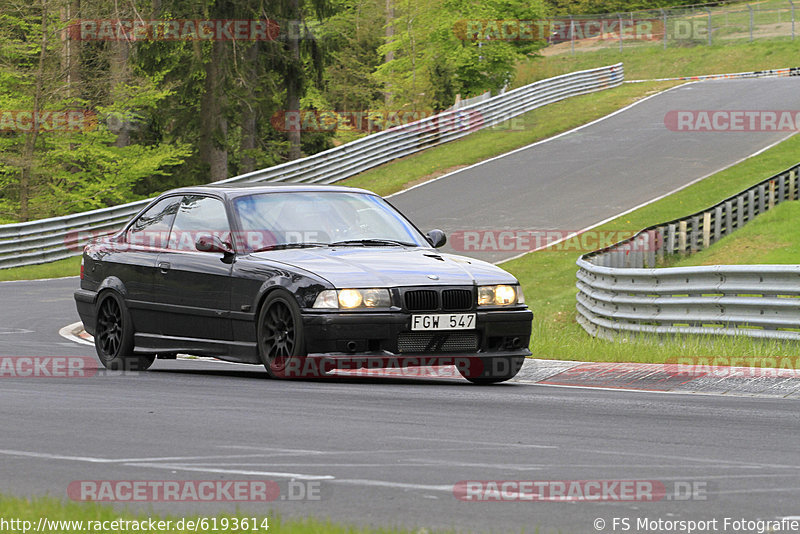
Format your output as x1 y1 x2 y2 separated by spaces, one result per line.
576 164 800 341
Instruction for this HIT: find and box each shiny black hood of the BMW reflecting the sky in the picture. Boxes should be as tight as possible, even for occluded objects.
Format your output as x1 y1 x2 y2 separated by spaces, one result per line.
251 247 516 288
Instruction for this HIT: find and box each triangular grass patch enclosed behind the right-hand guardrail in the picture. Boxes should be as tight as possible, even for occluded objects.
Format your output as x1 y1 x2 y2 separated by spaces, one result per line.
670 202 800 267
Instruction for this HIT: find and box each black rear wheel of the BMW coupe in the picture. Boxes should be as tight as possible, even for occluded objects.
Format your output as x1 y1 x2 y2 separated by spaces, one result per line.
94 291 155 371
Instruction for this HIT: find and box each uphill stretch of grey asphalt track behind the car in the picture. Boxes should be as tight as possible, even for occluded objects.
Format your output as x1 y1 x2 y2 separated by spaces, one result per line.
391 78 800 262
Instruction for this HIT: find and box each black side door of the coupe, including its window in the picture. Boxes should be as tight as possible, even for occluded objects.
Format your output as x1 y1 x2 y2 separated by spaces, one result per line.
155 195 232 340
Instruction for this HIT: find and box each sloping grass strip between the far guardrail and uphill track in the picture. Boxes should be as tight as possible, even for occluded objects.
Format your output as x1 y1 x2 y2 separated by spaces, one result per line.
338 78 676 196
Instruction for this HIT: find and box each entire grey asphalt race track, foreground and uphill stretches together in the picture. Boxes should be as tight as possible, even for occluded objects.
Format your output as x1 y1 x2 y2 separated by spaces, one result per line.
0 79 800 533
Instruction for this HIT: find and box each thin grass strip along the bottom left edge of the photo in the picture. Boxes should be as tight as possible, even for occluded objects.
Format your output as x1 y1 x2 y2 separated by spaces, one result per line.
0 495 439 534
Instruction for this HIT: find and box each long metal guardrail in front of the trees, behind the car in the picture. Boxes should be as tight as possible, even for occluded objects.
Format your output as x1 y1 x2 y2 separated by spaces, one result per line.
0 63 625 269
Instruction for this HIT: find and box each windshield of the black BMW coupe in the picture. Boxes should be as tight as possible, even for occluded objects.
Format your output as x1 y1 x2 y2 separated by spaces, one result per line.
233 191 430 251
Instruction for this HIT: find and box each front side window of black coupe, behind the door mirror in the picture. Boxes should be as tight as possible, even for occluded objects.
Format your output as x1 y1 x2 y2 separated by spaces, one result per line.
167 195 231 251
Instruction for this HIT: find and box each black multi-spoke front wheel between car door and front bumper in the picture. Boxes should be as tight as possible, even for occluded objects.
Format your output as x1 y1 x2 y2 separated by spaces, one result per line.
257 289 310 378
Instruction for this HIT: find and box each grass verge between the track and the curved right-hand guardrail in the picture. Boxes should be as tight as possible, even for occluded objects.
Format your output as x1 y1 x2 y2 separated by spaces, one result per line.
502 135 800 365
